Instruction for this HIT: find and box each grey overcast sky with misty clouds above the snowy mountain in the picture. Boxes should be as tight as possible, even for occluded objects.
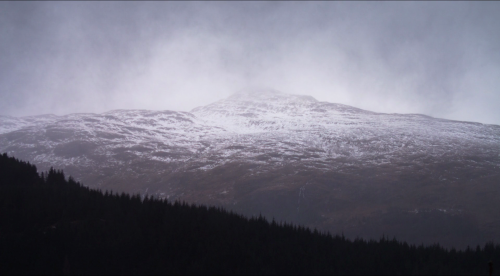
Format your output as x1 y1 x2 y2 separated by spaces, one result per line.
0 1 500 125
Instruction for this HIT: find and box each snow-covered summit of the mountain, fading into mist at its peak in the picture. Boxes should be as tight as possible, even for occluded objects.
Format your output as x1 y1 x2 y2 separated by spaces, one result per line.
191 89 371 133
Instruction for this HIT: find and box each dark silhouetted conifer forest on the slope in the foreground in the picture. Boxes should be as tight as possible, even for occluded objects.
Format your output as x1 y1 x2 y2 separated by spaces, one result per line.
0 154 500 275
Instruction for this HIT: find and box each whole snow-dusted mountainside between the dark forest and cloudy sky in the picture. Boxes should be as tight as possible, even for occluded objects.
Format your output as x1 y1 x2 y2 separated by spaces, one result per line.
0 90 500 247
